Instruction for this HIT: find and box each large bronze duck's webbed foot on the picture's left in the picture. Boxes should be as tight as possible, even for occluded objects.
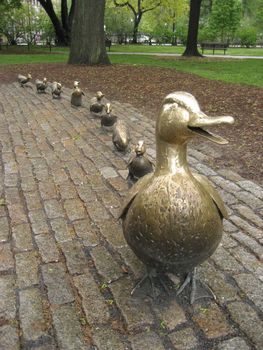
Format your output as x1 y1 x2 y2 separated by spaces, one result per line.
131 268 170 299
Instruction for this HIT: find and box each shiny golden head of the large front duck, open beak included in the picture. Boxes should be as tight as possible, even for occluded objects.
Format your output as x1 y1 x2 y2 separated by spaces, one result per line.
156 91 234 144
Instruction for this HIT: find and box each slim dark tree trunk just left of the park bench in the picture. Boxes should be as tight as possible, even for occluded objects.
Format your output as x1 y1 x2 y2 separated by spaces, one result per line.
183 0 202 57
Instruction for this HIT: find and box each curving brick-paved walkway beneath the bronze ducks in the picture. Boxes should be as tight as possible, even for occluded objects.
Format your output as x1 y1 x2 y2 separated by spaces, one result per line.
0 83 263 350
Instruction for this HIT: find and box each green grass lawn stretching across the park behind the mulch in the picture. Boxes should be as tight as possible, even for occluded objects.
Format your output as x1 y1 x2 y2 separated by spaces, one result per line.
0 45 263 87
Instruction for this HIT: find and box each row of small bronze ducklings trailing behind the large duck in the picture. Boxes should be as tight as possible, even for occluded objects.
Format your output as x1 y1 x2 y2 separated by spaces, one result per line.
18 74 154 186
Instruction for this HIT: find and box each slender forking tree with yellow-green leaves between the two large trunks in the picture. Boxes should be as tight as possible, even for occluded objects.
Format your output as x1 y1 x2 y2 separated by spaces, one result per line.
113 0 161 44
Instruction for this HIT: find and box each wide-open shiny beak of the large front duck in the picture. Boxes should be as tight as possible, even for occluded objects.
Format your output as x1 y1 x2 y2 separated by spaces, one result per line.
188 111 235 145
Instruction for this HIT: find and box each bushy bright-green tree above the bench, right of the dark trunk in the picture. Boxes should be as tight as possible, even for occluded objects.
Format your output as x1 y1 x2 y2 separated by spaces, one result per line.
210 0 242 42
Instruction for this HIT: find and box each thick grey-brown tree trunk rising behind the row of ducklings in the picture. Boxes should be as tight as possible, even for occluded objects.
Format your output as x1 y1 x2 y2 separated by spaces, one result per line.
68 0 110 65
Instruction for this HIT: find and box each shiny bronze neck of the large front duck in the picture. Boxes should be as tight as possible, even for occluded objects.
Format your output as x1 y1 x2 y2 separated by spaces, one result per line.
155 140 190 175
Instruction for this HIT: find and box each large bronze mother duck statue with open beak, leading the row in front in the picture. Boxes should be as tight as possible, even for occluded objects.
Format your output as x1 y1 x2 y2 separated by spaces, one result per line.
120 91 234 304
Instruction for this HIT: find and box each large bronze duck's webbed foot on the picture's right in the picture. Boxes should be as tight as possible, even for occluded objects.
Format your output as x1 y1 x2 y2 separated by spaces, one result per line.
176 267 216 305
